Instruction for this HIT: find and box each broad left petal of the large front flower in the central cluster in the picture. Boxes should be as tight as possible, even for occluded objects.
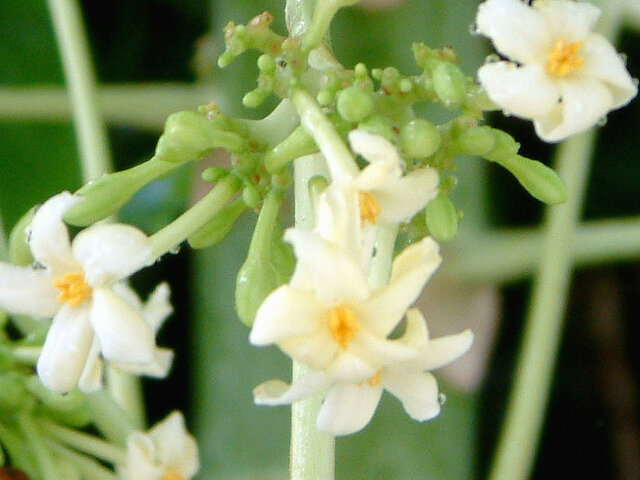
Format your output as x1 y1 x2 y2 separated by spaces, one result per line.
249 285 326 345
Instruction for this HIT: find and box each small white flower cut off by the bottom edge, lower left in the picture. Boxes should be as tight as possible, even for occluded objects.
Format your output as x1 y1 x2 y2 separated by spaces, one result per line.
123 411 200 480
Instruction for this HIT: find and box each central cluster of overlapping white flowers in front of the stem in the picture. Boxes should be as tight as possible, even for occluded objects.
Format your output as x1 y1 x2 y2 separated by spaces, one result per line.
250 130 473 435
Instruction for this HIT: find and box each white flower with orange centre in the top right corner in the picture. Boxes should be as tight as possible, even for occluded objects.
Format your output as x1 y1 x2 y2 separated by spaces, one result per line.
476 0 637 142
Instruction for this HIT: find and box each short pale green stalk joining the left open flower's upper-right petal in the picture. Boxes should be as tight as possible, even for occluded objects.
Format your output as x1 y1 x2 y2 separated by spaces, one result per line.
151 175 241 258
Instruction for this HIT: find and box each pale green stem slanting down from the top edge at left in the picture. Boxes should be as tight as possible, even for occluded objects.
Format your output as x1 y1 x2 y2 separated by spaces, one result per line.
49 0 111 182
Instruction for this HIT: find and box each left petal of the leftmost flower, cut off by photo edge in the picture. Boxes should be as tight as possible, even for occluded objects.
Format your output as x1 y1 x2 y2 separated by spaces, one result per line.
0 262 62 318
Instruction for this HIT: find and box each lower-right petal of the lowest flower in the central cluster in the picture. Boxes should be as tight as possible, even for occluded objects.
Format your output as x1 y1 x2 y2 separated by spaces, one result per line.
380 369 440 422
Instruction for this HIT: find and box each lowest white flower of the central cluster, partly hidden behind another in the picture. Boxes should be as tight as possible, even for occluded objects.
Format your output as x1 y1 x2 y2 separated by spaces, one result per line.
254 309 473 435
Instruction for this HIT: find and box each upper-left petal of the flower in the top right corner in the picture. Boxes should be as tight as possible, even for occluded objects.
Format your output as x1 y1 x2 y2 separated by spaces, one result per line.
476 0 550 63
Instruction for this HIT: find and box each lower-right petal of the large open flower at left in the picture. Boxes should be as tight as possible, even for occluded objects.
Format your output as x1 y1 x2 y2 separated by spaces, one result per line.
89 287 156 364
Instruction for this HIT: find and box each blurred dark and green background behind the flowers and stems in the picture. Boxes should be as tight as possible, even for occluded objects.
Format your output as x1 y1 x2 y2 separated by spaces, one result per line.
0 0 640 480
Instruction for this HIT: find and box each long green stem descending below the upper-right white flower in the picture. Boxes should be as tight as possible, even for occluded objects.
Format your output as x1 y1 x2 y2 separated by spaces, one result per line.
489 131 595 480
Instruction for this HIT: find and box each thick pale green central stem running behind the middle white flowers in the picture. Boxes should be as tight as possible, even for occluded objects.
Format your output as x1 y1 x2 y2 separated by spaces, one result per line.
290 155 335 480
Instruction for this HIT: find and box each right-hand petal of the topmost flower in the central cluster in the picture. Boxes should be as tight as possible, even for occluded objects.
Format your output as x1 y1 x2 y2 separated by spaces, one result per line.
373 167 440 224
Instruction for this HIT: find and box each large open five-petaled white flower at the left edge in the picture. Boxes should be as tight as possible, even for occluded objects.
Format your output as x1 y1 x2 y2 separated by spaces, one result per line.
0 192 158 392
